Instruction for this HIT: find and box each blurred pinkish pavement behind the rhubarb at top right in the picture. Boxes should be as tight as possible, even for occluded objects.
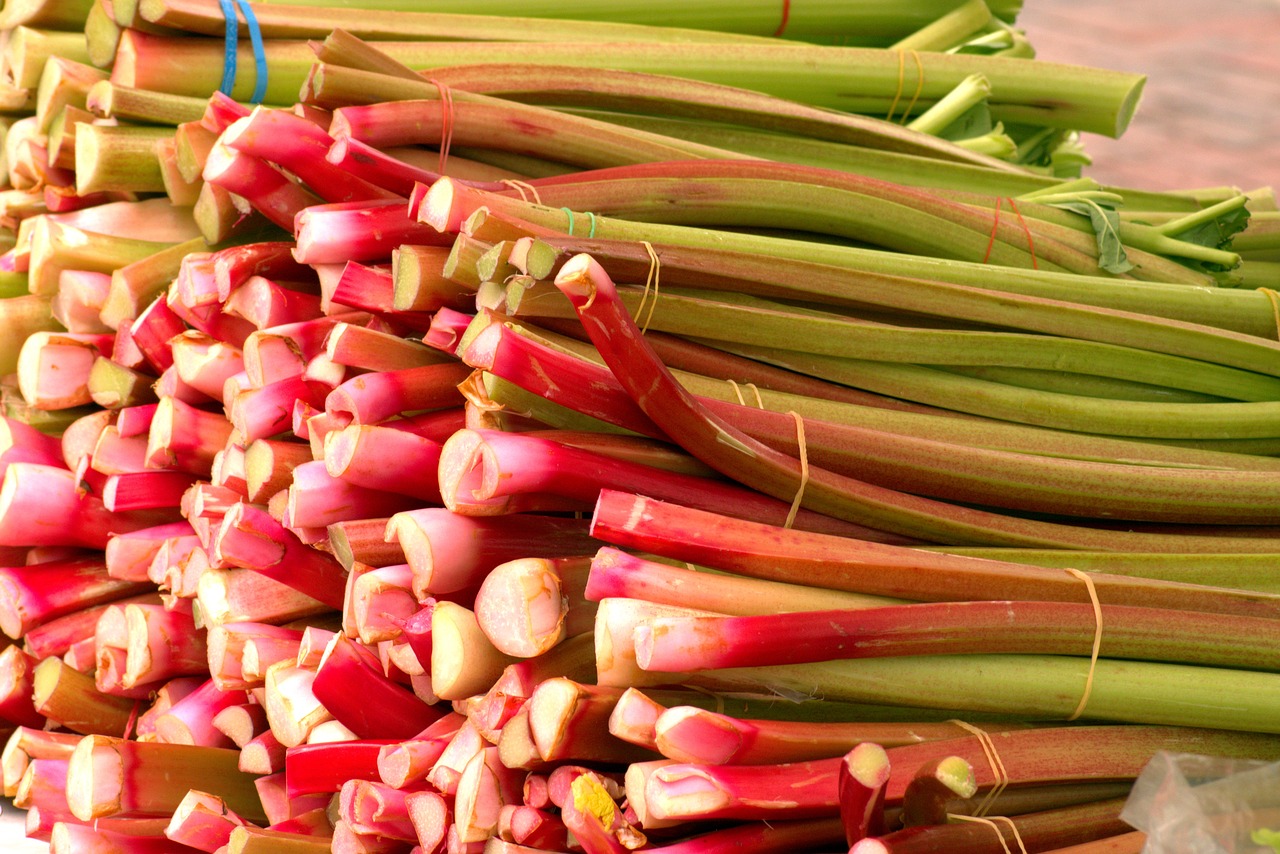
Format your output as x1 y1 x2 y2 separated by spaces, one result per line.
1018 0 1280 189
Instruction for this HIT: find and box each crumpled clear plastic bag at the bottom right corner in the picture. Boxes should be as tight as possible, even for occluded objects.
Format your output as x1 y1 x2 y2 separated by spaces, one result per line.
1120 752 1280 854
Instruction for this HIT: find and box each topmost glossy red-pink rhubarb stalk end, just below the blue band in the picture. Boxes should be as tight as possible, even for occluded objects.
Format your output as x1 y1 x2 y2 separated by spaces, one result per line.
221 106 399 202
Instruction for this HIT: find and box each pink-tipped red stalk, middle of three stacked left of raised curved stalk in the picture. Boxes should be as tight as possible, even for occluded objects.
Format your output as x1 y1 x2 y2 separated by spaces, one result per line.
325 362 471 424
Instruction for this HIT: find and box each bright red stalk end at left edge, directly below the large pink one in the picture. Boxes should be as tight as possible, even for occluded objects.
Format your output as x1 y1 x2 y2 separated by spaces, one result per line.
0 557 150 639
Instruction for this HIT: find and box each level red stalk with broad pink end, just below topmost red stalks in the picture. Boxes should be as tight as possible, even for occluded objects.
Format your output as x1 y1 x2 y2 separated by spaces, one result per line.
289 198 452 264
